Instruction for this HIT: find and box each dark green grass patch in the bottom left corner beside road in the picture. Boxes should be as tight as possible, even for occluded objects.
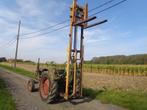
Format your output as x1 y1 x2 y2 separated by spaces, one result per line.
0 79 16 110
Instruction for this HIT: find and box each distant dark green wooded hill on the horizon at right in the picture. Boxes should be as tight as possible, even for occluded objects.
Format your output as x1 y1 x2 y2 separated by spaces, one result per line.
85 54 147 65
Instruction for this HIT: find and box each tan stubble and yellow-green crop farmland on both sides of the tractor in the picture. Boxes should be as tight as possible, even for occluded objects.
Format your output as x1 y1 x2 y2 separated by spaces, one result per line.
3 63 147 92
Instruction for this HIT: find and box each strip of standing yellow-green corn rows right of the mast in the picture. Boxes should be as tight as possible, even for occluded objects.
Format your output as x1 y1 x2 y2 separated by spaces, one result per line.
83 64 147 76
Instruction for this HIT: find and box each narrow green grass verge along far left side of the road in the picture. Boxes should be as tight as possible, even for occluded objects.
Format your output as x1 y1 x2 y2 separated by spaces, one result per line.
0 64 34 78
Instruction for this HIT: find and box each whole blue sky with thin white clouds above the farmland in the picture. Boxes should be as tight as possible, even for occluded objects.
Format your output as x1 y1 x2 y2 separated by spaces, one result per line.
0 0 147 63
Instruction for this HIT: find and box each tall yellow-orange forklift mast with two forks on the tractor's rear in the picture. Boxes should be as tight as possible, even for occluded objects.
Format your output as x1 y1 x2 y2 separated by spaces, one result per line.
64 0 107 100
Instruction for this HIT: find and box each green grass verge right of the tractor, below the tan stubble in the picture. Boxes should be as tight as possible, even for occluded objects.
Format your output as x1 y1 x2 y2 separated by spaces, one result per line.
84 89 147 110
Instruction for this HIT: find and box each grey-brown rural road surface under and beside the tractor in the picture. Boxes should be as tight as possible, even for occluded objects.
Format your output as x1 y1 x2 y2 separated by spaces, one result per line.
0 68 126 110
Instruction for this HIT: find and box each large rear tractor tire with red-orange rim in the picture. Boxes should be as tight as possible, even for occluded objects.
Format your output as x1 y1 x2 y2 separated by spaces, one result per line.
39 71 58 103
